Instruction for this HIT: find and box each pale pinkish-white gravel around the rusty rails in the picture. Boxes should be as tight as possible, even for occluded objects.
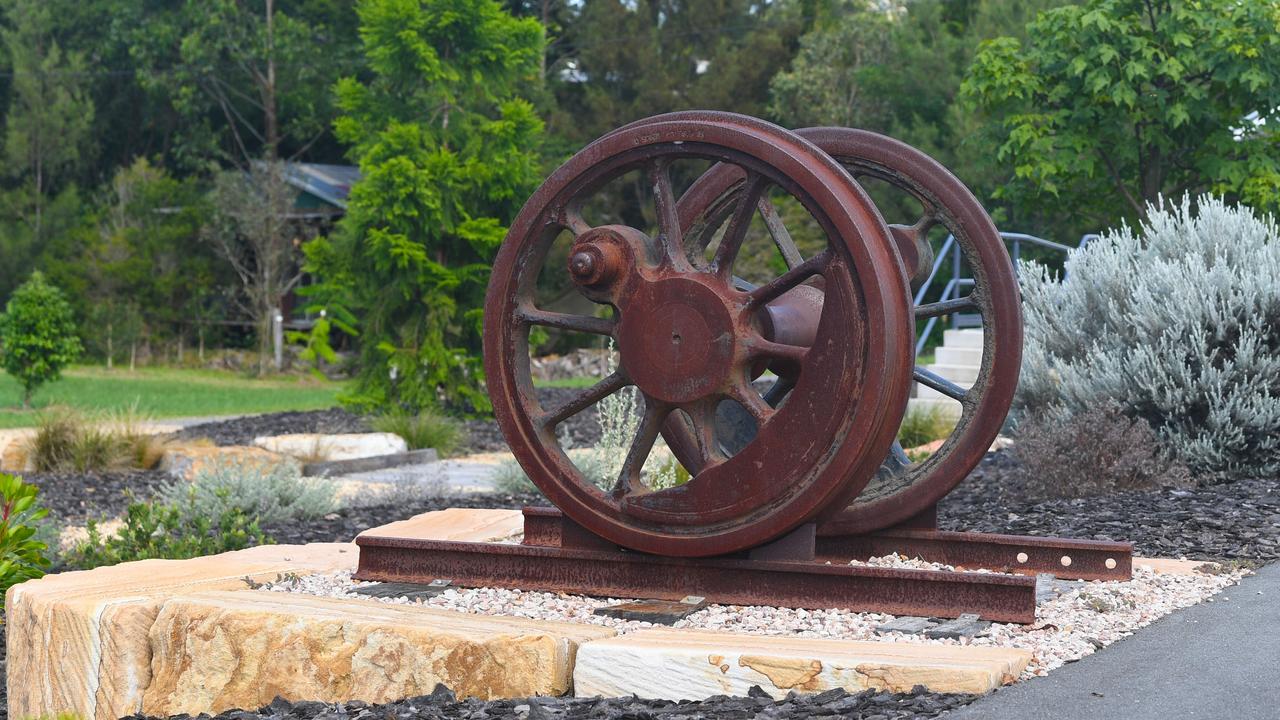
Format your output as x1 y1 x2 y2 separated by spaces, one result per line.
260 555 1248 679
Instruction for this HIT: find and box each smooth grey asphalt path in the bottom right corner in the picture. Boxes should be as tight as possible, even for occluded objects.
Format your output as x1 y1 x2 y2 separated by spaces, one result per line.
947 564 1280 720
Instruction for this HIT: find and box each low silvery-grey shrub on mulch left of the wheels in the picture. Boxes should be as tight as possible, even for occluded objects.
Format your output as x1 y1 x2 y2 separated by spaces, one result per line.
159 459 338 525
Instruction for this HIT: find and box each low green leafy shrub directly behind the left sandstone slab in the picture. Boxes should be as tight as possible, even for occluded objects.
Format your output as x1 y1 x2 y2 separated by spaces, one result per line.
63 493 271 570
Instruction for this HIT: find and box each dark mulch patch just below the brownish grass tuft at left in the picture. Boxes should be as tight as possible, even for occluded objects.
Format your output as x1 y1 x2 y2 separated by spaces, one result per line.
23 470 173 525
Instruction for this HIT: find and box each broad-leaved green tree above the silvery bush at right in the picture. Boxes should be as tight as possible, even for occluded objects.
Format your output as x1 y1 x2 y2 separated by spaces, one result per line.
964 0 1280 225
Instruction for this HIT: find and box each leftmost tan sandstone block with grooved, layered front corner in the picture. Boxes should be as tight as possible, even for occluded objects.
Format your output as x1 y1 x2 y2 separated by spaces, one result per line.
5 543 358 720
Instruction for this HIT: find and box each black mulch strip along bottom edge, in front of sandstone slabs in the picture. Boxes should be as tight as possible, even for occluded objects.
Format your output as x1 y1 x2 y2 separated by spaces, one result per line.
124 685 974 720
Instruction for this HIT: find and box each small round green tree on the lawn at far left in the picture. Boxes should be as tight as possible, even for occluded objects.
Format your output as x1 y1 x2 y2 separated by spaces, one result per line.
0 272 81 409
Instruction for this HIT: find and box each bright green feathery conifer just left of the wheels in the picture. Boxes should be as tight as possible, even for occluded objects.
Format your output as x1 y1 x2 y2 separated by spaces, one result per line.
307 0 543 410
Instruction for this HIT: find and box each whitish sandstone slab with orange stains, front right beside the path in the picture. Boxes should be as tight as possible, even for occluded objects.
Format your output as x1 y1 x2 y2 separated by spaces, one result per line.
573 629 1032 700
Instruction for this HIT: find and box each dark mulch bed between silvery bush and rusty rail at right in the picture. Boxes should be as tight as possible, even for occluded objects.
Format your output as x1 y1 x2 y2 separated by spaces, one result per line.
938 451 1280 561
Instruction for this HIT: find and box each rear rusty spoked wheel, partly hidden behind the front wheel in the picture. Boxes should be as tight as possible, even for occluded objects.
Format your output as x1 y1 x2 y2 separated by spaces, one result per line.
664 120 1023 534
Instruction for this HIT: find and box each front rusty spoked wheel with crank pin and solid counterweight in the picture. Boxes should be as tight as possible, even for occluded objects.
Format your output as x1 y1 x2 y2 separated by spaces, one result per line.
485 114 913 556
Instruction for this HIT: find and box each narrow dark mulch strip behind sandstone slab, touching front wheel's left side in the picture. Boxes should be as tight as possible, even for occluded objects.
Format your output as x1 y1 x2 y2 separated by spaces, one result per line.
262 493 547 544
